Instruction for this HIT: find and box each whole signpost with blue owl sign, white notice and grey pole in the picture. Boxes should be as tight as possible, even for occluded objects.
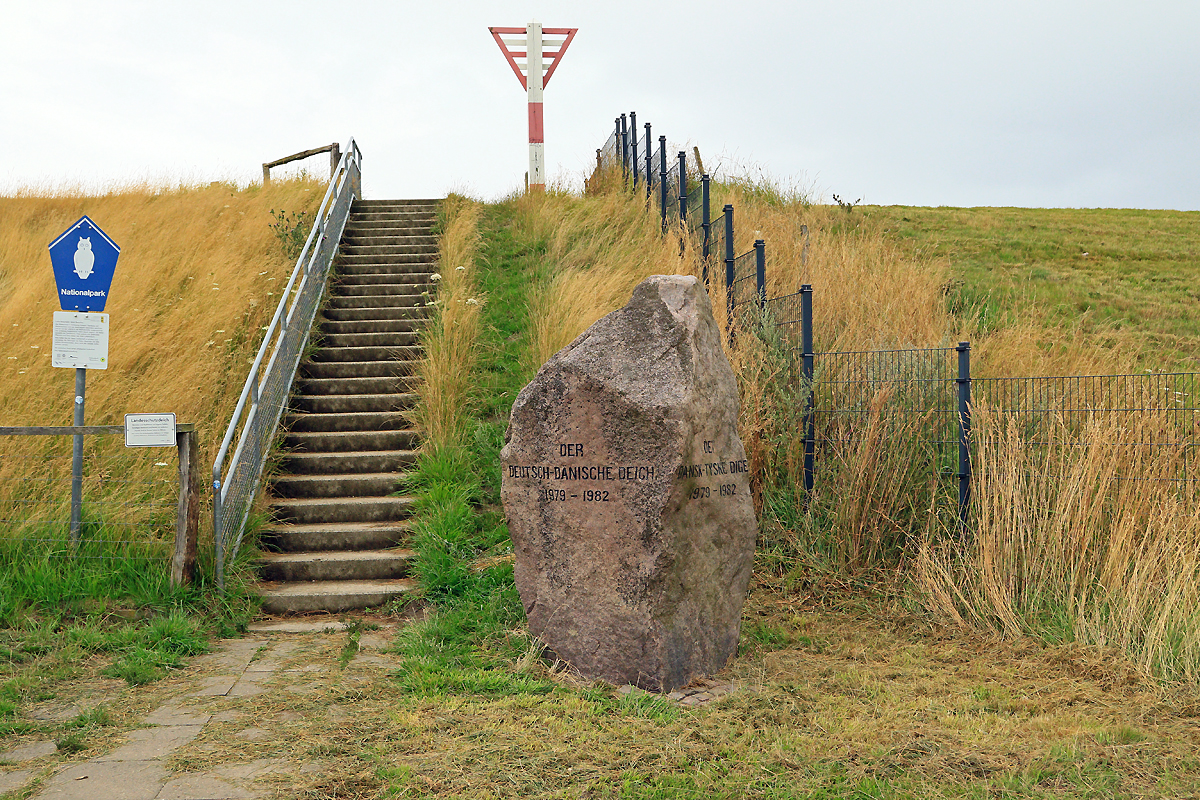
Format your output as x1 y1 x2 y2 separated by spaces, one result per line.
50 216 121 546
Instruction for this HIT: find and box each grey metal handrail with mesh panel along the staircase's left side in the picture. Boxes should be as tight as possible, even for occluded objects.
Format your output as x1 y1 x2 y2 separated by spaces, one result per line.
212 139 362 590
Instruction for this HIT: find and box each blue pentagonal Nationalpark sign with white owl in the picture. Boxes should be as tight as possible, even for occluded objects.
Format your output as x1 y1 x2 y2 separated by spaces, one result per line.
50 216 121 311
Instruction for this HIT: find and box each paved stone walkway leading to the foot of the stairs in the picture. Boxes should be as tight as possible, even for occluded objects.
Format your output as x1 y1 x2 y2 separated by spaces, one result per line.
0 621 374 800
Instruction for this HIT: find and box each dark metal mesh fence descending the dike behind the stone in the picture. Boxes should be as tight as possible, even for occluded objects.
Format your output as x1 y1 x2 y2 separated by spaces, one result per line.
592 114 1200 531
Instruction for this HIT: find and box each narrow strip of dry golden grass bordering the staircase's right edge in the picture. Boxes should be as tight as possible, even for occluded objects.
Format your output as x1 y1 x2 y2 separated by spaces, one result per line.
414 194 485 447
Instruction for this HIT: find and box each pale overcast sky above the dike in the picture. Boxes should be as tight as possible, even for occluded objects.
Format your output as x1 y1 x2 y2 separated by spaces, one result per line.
0 0 1200 210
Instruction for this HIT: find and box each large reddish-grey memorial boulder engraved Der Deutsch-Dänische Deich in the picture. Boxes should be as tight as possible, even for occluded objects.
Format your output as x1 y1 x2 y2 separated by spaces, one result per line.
502 276 757 691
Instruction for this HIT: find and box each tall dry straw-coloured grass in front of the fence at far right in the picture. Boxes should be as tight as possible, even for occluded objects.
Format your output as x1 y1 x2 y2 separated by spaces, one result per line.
916 408 1200 682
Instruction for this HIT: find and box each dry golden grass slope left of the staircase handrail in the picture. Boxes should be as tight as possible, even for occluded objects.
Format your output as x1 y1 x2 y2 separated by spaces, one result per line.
0 179 325 537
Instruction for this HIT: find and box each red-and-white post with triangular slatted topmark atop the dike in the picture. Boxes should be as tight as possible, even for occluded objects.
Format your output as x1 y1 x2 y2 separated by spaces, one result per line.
487 22 578 192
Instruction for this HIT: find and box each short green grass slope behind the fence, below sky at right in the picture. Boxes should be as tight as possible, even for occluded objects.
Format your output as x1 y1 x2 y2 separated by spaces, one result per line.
854 206 1200 369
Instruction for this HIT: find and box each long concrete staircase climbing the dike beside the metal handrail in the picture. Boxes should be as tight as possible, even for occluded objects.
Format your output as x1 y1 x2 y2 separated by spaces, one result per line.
259 200 438 614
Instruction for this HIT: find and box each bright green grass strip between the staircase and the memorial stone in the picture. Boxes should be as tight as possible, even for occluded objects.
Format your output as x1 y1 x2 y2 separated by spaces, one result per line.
394 204 552 696
